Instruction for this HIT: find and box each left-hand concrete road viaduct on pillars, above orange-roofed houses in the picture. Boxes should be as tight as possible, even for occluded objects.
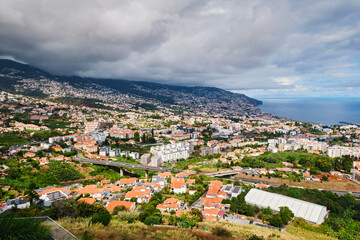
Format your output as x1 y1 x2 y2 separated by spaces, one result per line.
77 158 182 175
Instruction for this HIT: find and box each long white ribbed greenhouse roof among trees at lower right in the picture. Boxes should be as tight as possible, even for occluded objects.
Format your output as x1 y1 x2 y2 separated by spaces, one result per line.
245 188 327 224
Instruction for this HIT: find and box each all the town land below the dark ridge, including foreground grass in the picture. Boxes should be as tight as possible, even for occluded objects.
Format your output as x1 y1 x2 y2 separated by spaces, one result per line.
0 90 360 240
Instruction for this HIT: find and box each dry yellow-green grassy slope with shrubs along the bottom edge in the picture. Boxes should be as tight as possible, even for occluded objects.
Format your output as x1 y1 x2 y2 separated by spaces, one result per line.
55 216 334 240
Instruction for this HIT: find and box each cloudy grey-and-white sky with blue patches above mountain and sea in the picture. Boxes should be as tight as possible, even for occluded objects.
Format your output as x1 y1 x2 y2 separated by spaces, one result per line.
0 0 360 98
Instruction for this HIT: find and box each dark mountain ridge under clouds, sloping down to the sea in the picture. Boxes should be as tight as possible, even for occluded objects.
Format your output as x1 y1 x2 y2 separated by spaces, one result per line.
0 59 262 115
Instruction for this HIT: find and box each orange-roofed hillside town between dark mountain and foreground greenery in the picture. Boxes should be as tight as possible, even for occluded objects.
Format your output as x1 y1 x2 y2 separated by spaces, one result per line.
0 92 360 239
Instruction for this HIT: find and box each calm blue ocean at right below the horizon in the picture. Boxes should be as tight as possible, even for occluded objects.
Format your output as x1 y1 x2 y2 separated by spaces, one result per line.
259 98 360 125
